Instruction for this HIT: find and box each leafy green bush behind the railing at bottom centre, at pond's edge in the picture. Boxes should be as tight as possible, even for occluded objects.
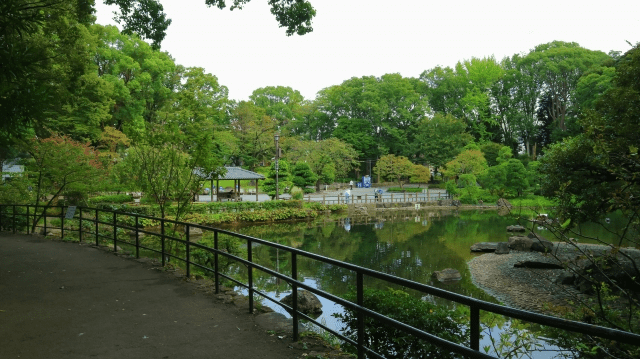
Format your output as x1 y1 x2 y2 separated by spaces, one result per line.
334 288 469 358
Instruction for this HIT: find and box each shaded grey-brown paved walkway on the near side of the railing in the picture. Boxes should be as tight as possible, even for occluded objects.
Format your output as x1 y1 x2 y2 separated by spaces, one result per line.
0 233 330 359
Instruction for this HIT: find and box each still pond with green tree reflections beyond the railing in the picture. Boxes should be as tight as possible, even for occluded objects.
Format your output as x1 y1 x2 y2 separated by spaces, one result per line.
212 210 622 357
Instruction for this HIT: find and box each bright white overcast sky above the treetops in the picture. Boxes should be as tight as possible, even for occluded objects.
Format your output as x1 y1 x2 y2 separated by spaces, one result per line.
96 0 640 100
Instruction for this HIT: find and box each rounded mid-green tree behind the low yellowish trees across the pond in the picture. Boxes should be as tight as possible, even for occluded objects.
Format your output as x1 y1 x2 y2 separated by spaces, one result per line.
412 113 472 177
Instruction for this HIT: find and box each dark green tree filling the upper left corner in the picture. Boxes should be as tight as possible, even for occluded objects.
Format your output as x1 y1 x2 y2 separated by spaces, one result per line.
0 0 92 148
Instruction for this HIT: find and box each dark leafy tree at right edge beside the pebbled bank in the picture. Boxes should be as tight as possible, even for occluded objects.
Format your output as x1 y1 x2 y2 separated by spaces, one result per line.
540 44 640 358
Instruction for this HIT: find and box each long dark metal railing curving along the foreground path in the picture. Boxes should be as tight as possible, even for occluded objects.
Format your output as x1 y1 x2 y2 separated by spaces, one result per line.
0 204 640 358
